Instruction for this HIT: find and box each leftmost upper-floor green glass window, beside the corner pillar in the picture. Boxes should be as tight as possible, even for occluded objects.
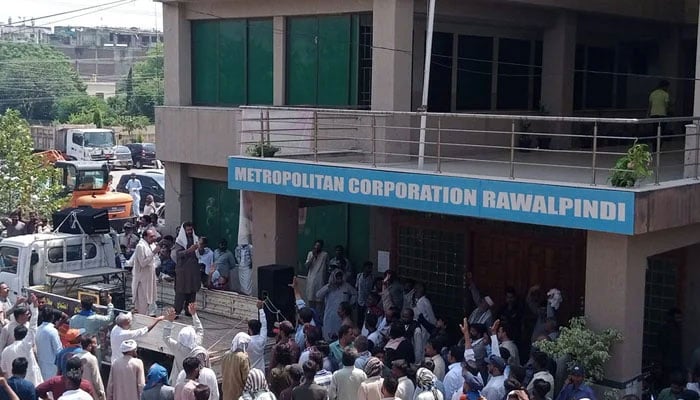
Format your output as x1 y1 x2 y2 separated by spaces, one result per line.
191 19 273 106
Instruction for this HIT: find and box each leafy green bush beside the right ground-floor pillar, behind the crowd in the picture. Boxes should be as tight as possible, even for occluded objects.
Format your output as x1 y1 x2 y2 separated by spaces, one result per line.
537 317 622 381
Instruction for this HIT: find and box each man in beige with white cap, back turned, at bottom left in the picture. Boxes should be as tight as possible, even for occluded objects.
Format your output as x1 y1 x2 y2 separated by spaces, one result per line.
107 339 146 400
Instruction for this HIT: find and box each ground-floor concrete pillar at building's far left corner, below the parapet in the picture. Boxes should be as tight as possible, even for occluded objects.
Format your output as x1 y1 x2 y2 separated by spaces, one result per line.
163 161 193 234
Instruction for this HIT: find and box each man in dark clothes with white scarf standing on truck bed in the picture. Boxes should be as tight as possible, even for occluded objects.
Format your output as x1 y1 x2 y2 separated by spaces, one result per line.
171 222 202 317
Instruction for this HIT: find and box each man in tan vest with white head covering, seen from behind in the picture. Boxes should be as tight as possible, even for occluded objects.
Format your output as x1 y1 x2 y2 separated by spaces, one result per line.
221 332 250 399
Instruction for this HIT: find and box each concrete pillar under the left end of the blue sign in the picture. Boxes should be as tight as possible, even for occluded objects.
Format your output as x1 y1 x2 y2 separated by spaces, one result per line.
249 192 299 296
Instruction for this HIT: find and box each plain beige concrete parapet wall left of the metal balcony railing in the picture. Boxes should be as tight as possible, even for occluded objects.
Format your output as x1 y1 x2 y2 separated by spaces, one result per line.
156 107 241 167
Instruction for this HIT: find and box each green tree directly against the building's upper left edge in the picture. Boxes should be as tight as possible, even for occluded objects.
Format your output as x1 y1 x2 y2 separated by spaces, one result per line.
126 44 165 121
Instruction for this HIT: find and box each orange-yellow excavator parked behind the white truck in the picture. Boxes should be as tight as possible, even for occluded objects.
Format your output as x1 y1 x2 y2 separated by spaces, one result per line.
37 150 135 231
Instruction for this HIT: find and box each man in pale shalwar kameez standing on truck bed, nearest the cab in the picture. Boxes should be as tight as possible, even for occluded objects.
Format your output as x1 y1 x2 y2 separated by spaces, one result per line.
131 228 160 316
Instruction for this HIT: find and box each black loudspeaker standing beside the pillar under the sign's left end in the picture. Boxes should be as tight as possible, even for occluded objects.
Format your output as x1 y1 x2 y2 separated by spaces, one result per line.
258 264 296 337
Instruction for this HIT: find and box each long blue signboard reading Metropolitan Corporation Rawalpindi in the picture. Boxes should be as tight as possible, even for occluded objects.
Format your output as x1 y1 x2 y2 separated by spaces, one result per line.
228 157 634 234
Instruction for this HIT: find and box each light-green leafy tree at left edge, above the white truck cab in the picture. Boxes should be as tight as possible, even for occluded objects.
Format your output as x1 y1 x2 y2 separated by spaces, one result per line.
0 110 66 217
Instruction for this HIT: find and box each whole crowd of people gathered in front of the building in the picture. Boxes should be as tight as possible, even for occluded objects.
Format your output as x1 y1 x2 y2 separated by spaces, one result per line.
0 212 700 400
